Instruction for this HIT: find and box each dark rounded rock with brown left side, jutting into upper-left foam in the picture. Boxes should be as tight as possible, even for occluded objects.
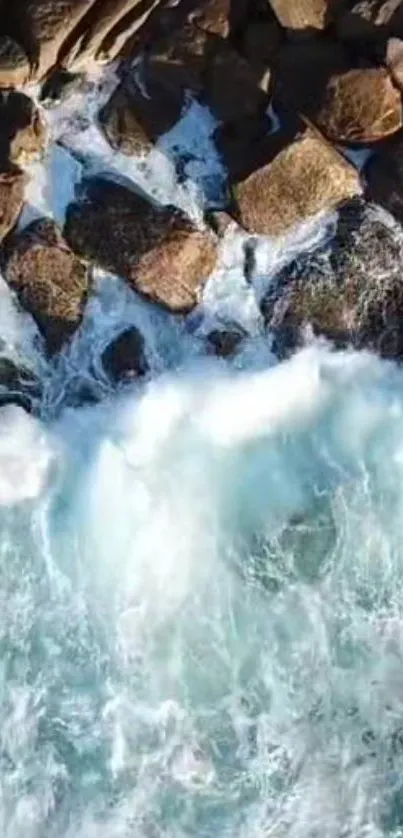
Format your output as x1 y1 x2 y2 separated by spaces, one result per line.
99 78 183 154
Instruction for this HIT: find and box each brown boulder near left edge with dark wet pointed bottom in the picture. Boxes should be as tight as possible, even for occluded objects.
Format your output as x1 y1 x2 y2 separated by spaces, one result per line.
5 219 88 354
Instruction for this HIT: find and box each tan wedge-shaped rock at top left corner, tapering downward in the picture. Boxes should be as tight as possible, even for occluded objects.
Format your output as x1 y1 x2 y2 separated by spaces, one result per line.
5 0 96 79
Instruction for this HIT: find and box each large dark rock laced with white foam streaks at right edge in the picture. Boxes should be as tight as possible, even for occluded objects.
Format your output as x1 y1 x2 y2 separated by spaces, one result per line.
262 201 403 358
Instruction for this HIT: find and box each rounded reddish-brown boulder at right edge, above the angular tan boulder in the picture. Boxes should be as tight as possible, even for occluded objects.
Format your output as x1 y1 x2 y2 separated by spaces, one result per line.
315 67 403 144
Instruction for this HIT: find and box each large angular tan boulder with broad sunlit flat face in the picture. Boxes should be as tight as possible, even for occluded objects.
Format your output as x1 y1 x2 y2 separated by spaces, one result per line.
234 128 361 236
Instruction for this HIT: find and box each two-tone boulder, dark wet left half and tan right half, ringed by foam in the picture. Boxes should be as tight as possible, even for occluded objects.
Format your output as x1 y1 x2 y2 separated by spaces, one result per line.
65 179 216 312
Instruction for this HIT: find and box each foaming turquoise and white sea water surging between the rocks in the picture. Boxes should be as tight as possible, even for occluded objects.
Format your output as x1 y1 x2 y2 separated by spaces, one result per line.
0 70 403 838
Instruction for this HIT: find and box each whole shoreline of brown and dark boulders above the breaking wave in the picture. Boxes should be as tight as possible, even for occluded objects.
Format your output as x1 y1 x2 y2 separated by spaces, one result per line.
0 0 403 406
